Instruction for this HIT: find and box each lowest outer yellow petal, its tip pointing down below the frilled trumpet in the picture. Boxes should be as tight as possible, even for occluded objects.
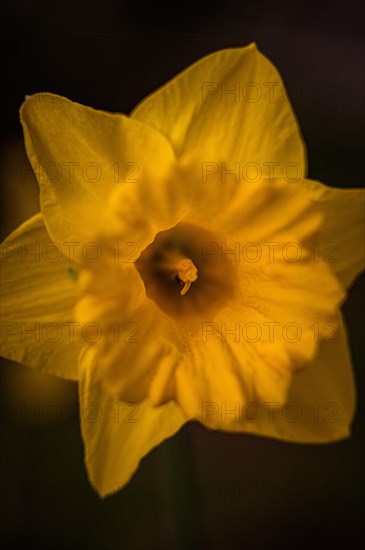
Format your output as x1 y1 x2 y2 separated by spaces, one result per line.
80 350 187 497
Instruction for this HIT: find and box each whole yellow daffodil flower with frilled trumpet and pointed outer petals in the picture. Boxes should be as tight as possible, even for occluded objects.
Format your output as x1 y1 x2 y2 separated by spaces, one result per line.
2 44 364 496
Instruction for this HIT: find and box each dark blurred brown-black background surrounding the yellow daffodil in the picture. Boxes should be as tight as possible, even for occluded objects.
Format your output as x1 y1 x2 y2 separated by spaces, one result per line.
0 0 365 550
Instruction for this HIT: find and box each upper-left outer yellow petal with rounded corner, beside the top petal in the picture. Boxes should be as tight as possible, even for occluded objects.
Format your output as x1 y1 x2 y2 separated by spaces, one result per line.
20 94 174 250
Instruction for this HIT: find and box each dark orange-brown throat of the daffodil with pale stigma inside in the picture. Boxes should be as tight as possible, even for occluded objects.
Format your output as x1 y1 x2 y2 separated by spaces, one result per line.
135 223 235 320
